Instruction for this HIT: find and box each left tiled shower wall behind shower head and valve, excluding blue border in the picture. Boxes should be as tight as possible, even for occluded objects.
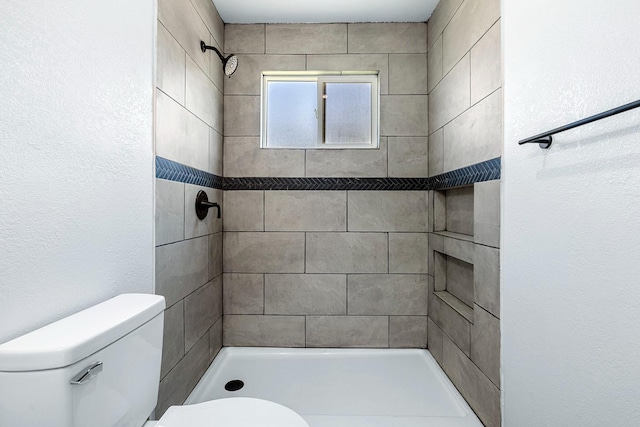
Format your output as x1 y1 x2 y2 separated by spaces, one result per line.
156 0 224 417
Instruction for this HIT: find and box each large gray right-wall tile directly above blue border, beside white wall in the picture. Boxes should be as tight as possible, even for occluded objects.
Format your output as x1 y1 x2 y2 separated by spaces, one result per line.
444 90 502 172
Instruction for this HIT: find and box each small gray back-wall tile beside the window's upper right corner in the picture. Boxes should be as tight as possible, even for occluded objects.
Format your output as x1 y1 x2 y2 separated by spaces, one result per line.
389 53 427 95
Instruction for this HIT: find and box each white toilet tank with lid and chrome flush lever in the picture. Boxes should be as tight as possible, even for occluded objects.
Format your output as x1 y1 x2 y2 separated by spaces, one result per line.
0 294 165 427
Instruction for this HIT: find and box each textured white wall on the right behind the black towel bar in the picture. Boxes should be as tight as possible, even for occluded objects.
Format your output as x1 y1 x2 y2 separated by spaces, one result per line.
502 0 640 427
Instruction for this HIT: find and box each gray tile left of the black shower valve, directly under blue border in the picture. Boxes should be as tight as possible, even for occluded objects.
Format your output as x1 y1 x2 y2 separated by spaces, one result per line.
156 179 184 246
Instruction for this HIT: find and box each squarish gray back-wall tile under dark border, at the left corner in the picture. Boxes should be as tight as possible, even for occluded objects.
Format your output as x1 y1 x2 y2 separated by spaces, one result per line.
224 191 264 231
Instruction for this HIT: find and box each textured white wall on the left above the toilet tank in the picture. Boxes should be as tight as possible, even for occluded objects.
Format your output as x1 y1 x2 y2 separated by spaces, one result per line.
0 0 155 342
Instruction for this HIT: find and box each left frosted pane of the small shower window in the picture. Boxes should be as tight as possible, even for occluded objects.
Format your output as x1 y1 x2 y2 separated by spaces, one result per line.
267 81 318 148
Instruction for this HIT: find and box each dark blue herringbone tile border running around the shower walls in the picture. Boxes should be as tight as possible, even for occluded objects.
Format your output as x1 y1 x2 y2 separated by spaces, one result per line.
156 157 500 191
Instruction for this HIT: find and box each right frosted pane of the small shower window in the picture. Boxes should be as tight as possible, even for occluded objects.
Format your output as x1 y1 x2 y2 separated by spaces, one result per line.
324 83 371 144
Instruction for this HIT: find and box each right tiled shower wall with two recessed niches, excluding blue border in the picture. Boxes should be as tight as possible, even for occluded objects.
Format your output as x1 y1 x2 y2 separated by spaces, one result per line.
427 0 502 426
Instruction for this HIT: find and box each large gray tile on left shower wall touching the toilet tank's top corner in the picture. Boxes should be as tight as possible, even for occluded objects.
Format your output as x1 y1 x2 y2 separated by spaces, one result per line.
156 236 209 306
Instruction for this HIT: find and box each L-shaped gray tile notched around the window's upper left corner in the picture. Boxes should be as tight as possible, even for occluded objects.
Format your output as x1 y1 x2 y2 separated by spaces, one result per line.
224 54 305 95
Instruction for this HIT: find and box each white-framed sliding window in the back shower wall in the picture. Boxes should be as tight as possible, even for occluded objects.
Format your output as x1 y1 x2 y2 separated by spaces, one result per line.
261 71 379 149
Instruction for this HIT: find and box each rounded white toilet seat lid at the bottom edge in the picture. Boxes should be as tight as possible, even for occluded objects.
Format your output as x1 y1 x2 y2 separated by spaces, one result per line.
156 397 309 427
